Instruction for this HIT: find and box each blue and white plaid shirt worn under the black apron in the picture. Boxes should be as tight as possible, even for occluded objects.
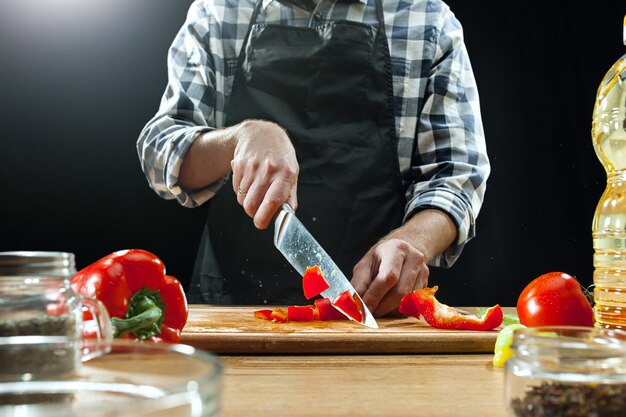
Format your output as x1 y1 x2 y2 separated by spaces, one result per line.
137 0 490 266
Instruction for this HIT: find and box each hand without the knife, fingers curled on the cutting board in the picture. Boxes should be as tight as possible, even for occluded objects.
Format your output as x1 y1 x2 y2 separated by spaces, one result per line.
352 239 429 317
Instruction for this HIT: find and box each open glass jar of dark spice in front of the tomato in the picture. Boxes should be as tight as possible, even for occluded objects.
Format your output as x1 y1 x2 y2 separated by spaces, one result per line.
505 326 626 417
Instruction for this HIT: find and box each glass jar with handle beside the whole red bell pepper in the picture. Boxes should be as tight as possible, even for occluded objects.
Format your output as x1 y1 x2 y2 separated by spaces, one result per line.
0 252 113 374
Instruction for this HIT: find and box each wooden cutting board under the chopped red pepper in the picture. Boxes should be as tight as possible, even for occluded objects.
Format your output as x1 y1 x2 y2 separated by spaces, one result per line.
181 305 510 354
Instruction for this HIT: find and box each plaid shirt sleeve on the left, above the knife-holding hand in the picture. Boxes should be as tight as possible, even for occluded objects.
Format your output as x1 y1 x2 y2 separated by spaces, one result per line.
137 2 226 207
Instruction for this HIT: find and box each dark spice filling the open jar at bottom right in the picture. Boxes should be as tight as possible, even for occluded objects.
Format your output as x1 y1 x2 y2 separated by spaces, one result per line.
511 382 626 417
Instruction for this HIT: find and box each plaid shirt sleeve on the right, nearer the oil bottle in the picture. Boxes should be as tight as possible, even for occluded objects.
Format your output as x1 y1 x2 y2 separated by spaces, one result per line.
406 7 490 267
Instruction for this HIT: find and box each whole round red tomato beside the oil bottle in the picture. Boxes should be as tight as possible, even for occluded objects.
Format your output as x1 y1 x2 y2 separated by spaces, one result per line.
517 272 593 327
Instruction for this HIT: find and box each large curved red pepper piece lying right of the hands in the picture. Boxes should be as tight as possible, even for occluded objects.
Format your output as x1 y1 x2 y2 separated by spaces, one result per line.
398 285 503 330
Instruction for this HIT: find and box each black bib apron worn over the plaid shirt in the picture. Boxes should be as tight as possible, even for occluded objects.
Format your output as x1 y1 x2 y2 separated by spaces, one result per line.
188 0 405 305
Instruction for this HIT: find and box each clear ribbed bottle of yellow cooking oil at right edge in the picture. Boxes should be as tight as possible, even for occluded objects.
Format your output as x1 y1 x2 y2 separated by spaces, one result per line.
591 16 626 329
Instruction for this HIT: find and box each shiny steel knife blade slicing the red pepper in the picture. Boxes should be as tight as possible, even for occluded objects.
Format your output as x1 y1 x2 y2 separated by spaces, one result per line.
274 204 378 329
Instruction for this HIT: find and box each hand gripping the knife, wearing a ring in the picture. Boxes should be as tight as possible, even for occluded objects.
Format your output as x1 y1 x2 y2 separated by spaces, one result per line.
231 120 299 229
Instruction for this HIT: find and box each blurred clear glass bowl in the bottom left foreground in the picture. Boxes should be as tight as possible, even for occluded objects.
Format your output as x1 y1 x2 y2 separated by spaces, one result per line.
0 336 222 417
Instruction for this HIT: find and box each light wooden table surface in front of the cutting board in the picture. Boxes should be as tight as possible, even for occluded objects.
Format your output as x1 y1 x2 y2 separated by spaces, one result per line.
220 354 507 417
